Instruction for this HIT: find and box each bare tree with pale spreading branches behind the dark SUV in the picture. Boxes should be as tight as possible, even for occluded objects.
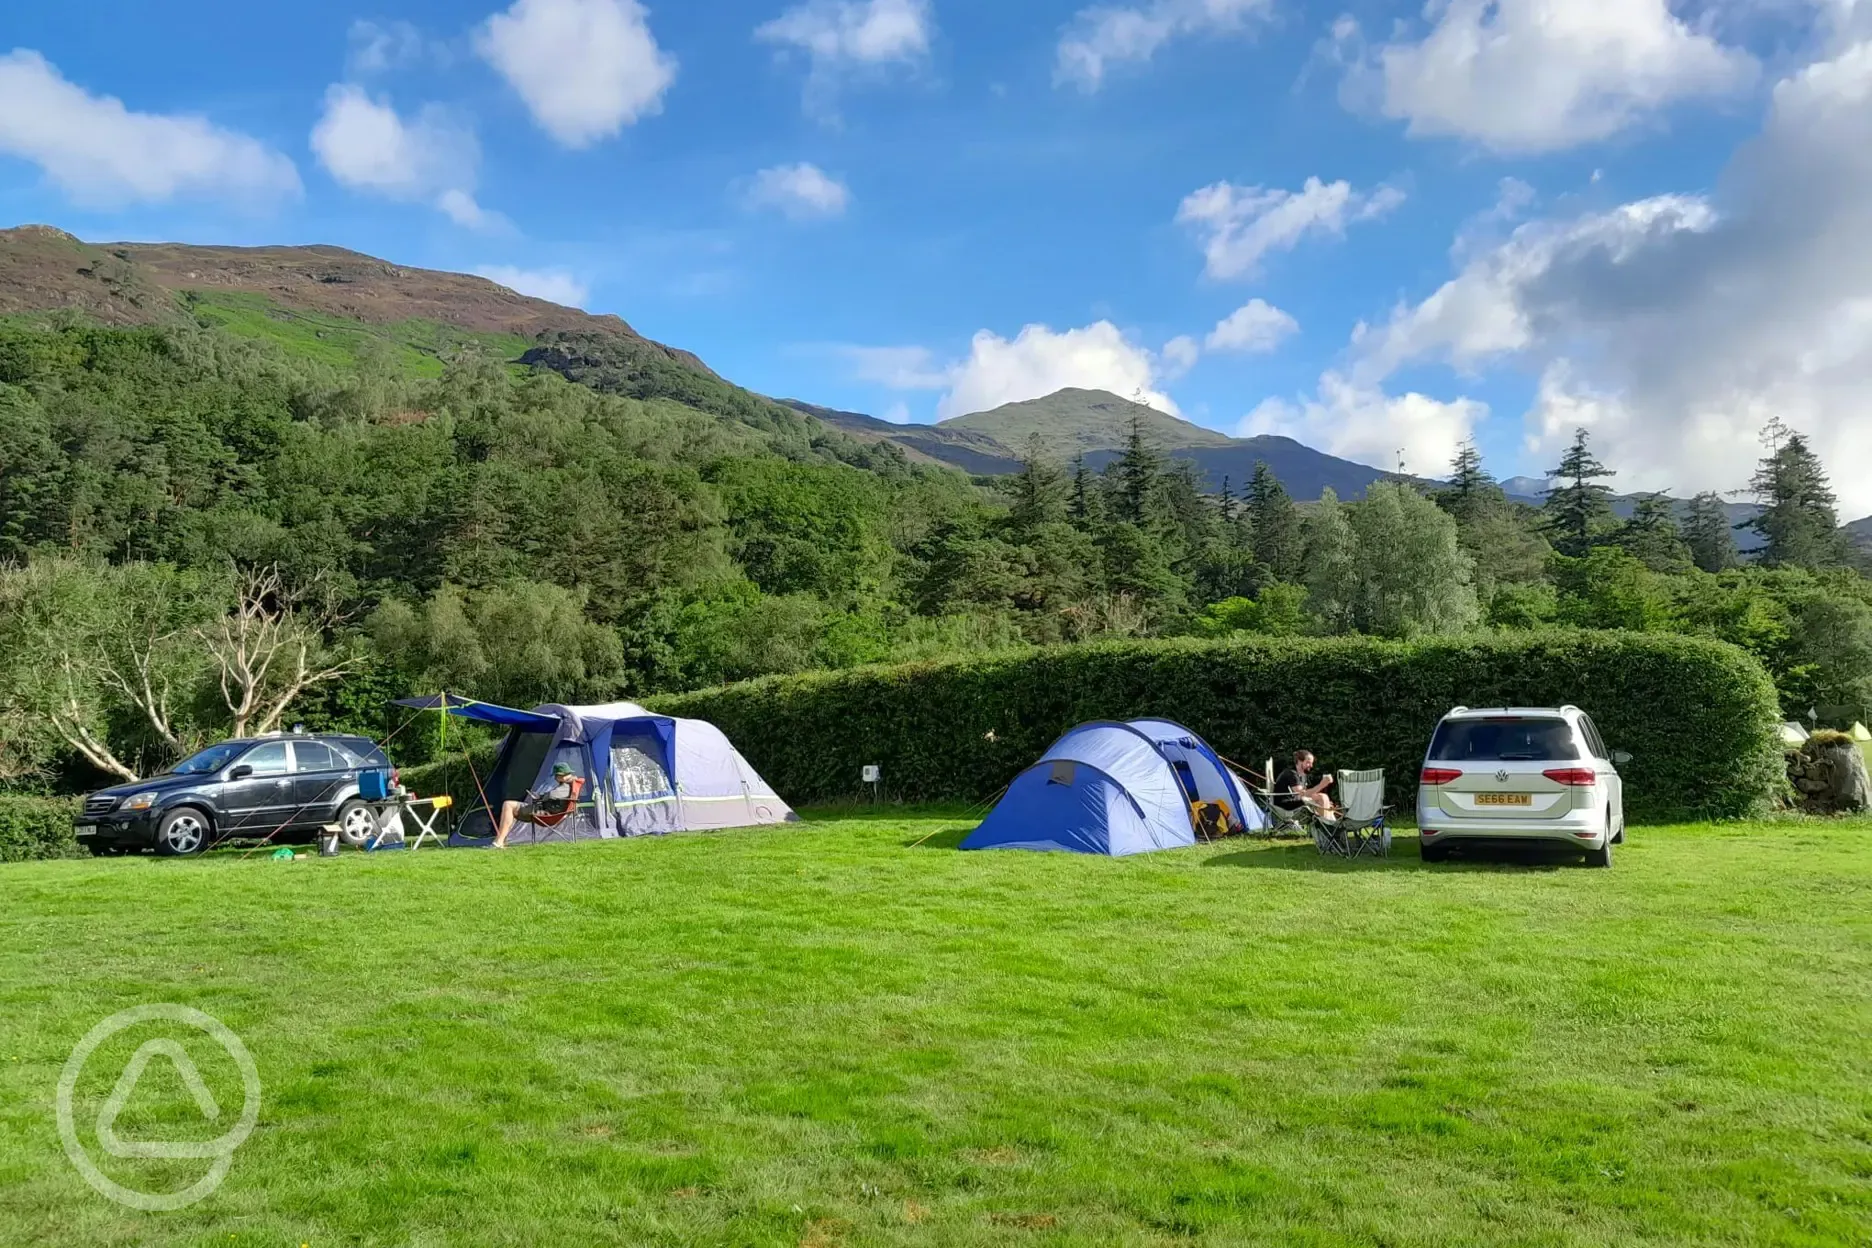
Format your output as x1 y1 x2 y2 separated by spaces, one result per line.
195 567 354 737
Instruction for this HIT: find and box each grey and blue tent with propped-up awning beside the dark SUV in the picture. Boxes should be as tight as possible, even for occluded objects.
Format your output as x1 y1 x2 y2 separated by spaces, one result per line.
397 694 799 846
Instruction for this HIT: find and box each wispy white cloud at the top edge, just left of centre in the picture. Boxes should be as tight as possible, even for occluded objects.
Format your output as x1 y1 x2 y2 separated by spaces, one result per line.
754 0 936 122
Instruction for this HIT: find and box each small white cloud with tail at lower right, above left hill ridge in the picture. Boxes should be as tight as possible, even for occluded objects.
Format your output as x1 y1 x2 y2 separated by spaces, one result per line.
311 82 505 228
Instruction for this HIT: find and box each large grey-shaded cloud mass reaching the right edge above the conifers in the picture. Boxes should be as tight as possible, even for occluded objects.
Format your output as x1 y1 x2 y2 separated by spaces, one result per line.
1355 32 1872 516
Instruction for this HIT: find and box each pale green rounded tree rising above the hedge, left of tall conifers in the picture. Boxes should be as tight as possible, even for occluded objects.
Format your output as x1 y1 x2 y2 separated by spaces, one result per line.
1348 481 1481 638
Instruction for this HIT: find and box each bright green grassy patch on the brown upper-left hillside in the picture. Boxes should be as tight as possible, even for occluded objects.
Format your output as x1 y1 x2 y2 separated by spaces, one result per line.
189 290 532 378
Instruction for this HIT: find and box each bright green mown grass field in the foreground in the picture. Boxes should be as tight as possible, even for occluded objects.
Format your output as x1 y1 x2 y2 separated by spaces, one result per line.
0 812 1872 1248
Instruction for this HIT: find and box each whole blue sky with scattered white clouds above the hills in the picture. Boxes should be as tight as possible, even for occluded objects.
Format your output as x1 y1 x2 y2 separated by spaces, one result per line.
0 0 1872 515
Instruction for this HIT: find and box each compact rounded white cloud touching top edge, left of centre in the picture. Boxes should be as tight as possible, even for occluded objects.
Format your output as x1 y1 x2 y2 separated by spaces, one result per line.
474 0 676 148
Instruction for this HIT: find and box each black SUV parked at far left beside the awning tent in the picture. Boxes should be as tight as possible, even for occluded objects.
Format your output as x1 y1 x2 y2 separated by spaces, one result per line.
73 733 389 857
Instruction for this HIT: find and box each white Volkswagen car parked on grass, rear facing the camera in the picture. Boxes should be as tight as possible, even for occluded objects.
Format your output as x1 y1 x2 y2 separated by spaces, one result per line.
1417 705 1631 866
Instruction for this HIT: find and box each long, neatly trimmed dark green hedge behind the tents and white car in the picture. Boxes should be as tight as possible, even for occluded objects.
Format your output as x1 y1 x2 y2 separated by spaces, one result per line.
651 632 1782 820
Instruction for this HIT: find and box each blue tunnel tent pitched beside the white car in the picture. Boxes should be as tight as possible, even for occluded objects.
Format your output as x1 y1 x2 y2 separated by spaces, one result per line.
962 718 1267 857
